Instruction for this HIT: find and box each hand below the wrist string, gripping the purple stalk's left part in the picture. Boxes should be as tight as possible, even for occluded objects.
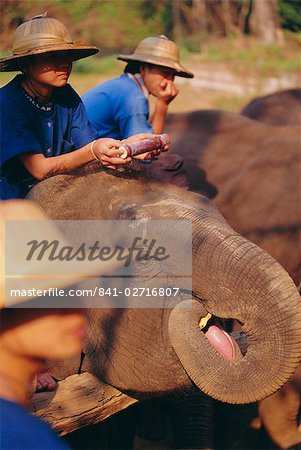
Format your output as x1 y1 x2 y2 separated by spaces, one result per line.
93 138 131 169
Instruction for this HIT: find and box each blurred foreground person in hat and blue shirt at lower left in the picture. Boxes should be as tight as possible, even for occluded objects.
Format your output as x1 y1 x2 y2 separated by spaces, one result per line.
0 200 85 450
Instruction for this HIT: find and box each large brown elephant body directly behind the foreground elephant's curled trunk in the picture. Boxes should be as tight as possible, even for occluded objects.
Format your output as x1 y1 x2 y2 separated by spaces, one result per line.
167 110 301 283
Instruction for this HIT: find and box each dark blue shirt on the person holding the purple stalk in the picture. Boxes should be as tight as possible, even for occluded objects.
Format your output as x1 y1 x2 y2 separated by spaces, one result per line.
0 75 96 200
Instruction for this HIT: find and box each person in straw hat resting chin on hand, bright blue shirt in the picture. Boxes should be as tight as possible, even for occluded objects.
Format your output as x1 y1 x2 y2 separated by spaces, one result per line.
82 35 193 188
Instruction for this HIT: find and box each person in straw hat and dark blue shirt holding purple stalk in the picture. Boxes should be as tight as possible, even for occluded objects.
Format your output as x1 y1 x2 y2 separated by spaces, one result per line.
0 14 155 199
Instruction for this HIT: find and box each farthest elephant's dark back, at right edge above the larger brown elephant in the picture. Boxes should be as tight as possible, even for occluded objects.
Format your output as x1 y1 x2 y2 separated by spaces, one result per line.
241 88 301 126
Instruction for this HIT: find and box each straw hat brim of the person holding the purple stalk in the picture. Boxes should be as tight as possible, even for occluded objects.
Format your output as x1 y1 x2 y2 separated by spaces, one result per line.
0 44 99 72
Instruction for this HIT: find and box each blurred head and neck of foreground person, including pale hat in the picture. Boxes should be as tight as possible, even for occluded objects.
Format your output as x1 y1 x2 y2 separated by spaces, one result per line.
0 200 85 404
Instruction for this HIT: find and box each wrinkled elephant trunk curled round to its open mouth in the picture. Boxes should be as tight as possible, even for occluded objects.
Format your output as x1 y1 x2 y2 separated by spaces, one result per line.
169 221 301 403
